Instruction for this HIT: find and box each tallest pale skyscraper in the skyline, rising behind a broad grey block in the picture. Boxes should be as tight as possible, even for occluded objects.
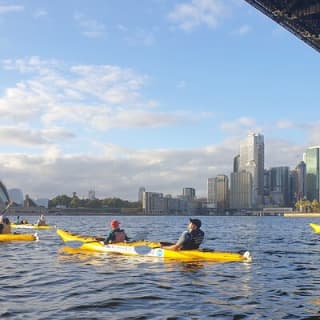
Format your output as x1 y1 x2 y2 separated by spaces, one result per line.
239 133 264 208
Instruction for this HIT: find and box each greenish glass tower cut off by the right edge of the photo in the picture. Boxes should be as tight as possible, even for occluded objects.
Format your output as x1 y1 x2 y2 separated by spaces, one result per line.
304 146 320 201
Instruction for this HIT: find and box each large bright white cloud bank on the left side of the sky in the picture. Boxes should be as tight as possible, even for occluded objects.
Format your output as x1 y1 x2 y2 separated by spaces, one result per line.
0 57 202 145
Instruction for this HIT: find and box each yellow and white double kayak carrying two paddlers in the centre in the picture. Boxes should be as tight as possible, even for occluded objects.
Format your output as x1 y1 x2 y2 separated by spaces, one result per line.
57 229 251 262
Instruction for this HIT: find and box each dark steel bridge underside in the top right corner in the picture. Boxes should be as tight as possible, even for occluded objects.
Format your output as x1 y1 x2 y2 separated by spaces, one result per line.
245 0 320 52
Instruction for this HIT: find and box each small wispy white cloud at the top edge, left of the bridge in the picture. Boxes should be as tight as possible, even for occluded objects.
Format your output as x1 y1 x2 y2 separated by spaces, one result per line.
168 0 228 31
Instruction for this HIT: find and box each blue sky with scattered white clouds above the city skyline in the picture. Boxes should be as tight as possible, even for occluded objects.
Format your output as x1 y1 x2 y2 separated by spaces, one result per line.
0 0 320 200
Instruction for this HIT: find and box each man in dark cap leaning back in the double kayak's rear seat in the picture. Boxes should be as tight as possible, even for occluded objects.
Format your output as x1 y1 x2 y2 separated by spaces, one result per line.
161 219 204 250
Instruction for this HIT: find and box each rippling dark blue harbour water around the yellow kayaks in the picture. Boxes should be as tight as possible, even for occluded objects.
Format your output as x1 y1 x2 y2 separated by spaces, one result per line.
0 216 320 320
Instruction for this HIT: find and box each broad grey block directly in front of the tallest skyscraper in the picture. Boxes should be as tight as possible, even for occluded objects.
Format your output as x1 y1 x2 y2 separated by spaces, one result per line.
230 170 252 210
